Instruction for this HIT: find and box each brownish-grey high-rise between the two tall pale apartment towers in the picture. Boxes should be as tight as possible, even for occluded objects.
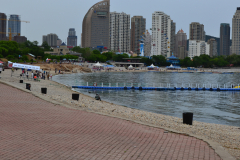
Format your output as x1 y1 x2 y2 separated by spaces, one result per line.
131 16 146 54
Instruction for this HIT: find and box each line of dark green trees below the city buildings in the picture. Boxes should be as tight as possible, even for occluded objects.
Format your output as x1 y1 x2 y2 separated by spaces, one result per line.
0 41 240 68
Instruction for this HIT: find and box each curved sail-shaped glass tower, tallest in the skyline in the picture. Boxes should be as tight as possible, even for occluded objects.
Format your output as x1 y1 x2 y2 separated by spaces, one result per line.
82 0 110 48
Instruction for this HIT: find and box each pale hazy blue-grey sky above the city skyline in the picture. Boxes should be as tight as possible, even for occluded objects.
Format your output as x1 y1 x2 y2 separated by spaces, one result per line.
0 0 240 45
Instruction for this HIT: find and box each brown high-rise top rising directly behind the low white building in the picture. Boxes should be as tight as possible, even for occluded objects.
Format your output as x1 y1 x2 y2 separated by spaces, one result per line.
189 22 205 41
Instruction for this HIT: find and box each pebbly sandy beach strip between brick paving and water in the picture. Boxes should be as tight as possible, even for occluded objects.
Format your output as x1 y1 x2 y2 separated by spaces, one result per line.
0 67 240 159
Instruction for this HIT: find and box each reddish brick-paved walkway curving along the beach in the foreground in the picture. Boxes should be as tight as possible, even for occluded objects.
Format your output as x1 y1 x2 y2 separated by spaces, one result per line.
0 83 220 160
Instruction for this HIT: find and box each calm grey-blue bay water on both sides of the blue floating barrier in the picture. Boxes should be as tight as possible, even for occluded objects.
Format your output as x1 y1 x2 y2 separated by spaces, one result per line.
53 72 240 126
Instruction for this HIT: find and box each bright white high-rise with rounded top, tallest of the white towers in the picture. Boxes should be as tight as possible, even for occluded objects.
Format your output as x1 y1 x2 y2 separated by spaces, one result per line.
151 11 171 57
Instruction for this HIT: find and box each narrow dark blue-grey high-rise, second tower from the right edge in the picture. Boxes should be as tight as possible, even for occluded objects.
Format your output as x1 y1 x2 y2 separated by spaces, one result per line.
220 23 230 56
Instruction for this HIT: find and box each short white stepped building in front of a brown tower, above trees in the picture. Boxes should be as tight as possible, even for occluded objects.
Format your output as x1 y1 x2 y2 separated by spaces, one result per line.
188 40 210 59
